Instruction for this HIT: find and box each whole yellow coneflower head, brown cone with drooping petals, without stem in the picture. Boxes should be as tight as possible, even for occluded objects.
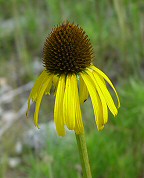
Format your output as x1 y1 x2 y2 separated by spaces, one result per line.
27 22 120 136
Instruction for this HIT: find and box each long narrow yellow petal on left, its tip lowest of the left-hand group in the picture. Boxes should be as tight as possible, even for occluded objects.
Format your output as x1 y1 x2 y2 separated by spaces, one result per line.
34 75 53 127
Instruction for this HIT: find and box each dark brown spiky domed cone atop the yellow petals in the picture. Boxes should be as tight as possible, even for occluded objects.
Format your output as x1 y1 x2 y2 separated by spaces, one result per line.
43 22 93 75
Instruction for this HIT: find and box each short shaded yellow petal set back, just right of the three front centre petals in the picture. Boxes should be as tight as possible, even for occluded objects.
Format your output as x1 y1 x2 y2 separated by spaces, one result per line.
79 77 88 104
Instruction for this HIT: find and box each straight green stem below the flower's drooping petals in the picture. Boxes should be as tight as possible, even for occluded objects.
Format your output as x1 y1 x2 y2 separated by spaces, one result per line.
75 134 92 178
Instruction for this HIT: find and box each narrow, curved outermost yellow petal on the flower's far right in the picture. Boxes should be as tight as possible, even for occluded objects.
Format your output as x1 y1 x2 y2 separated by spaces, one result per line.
90 65 120 108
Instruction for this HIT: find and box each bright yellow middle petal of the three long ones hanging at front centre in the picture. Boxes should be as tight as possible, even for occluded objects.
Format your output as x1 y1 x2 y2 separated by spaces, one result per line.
63 75 77 130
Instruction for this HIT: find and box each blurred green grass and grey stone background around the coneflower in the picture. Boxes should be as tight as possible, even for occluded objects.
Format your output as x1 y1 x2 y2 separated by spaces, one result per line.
0 0 144 178
